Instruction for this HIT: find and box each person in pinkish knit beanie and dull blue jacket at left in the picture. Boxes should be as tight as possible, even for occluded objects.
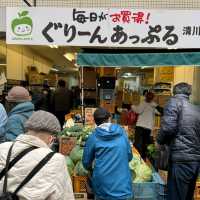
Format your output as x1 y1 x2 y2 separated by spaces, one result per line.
5 86 34 141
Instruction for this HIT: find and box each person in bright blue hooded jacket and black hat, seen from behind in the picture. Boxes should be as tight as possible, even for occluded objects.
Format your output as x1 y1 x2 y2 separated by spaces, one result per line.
83 108 133 200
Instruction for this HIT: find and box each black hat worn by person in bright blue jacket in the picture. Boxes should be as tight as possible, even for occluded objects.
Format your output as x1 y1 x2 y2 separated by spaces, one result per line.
94 107 111 126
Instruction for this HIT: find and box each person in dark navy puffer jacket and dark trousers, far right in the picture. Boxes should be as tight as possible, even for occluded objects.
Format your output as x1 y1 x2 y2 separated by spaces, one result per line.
157 83 200 200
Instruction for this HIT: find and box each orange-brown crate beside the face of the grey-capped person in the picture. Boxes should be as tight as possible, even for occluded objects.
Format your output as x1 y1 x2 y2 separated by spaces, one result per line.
59 136 77 155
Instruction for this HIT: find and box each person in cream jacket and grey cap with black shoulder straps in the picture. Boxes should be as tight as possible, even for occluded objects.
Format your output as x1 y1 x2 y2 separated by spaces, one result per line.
0 110 75 200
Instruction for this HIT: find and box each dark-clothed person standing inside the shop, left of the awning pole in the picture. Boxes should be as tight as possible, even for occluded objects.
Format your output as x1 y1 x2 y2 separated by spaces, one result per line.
52 80 72 126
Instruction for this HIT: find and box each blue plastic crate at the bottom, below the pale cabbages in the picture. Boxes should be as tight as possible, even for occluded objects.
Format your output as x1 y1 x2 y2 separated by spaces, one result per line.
133 173 167 200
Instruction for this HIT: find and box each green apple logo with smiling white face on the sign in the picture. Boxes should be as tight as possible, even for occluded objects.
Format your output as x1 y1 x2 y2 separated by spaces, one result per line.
12 11 33 36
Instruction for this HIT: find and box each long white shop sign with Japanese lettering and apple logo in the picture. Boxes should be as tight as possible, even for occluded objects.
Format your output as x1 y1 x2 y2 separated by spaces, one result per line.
6 7 200 49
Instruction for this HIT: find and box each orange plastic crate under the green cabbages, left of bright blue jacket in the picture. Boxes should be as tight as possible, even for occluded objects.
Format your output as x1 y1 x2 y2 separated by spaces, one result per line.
73 176 87 193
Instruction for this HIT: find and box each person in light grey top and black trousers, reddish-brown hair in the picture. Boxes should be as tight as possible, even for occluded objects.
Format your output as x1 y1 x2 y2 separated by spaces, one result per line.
132 92 162 160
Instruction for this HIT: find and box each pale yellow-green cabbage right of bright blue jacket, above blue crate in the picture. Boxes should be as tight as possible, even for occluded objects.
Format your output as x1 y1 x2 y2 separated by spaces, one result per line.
129 157 152 183
